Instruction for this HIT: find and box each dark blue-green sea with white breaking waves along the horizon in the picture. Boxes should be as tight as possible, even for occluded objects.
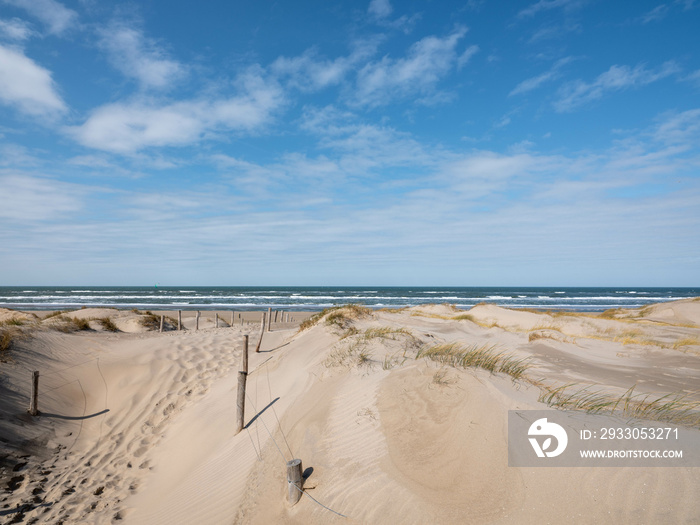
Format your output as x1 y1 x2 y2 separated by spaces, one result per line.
0 285 700 312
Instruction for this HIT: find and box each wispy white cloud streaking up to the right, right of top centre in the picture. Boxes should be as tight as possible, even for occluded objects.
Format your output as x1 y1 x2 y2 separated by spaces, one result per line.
354 28 467 106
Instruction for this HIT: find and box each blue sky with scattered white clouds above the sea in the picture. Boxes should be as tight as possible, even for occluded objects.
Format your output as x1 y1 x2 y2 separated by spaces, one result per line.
0 0 700 286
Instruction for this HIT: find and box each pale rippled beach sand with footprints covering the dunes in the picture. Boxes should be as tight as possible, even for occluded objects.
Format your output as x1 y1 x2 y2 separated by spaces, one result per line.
0 300 700 525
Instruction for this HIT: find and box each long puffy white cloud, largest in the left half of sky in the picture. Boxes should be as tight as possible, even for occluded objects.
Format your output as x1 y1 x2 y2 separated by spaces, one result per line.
66 69 283 153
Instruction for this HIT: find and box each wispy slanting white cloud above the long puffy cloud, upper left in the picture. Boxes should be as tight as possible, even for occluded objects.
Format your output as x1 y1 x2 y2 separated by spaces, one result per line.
100 24 185 88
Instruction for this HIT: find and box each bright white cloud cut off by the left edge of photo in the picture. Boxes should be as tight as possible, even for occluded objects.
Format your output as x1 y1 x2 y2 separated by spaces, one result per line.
0 45 66 118
